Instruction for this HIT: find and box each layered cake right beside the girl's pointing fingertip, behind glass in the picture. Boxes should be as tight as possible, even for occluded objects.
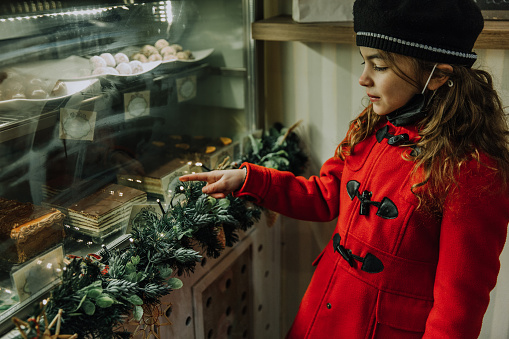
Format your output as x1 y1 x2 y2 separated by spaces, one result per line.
117 159 190 202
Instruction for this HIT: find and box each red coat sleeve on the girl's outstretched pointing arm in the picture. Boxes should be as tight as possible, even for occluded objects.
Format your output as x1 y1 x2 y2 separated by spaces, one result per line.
234 157 344 221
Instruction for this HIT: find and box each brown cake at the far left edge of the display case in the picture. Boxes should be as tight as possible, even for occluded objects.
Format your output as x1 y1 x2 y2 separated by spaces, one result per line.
0 198 64 264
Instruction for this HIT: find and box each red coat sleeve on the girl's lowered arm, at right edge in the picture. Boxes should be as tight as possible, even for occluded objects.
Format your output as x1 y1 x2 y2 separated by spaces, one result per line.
423 159 509 339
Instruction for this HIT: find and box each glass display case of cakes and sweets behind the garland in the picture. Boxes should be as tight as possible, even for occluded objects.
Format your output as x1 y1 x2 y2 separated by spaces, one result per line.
0 0 257 333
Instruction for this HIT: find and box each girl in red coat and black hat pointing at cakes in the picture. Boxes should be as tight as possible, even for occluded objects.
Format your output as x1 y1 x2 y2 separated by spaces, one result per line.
181 0 509 339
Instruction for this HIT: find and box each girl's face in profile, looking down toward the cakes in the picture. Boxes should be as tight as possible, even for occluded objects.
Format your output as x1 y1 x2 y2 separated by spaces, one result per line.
359 47 420 115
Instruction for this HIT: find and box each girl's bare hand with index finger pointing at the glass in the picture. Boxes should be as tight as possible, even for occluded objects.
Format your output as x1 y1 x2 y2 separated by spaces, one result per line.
179 168 247 199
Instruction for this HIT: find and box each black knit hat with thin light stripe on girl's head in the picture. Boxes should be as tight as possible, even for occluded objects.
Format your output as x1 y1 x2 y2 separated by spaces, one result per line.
353 0 484 67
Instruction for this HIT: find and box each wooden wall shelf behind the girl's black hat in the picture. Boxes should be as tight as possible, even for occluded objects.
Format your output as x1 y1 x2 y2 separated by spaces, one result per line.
252 15 509 49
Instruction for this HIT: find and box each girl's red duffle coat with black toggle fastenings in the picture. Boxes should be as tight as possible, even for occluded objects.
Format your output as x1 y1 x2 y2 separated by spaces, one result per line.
236 123 509 339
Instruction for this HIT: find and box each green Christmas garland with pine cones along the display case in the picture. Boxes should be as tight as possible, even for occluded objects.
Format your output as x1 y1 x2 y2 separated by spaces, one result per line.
13 125 307 339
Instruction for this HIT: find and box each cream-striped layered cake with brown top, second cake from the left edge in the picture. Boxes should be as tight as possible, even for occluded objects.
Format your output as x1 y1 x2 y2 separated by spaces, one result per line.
66 184 147 238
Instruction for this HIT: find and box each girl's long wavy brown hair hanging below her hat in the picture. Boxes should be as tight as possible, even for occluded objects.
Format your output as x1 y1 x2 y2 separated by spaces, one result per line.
336 51 509 209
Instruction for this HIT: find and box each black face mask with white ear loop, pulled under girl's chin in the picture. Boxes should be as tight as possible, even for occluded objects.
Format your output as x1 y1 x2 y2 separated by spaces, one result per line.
387 64 437 126
